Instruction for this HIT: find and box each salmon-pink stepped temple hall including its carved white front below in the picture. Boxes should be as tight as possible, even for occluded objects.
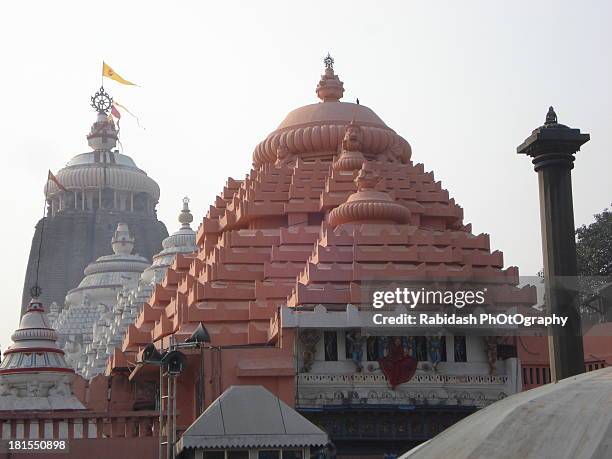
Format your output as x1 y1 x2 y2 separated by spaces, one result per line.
107 59 535 454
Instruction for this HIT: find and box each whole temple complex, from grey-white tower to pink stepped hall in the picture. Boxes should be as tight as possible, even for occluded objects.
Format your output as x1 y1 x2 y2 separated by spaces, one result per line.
0 55 605 459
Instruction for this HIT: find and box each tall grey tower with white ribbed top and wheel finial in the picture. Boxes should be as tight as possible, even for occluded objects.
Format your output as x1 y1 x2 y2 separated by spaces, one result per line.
22 88 168 314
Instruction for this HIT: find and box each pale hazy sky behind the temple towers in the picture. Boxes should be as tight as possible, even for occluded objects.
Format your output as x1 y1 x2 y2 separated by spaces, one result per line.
0 0 612 349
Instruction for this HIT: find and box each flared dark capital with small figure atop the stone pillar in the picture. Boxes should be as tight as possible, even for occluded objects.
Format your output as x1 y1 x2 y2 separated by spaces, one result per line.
516 107 591 172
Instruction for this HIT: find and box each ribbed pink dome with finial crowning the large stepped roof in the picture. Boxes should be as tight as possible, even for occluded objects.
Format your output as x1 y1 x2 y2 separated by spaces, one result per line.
253 56 411 166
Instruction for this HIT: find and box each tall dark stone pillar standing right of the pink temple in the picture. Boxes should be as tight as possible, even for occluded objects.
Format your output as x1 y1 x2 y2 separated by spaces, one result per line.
517 107 590 381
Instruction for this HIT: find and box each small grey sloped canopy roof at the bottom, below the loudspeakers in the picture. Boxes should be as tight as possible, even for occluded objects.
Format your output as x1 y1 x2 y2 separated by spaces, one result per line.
178 386 329 453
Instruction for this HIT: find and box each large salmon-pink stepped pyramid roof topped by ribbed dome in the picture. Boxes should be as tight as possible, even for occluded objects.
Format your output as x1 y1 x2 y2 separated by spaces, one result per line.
108 56 535 388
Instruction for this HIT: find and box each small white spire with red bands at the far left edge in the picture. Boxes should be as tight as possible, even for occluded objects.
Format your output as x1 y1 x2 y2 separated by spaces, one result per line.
0 299 84 411
